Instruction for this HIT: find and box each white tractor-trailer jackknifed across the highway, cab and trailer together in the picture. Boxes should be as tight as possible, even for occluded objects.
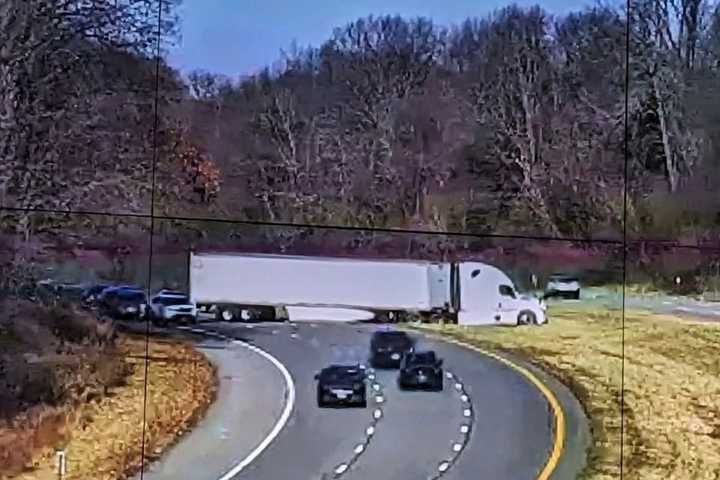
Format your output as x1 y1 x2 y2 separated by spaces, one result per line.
188 251 546 325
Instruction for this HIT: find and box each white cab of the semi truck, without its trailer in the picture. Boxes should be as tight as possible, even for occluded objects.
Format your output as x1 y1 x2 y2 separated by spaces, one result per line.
454 262 547 325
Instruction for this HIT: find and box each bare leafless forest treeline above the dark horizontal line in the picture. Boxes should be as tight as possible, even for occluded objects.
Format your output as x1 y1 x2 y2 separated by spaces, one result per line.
0 0 720 255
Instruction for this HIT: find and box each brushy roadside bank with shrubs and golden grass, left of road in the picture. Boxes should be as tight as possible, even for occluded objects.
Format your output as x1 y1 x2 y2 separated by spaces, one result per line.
0 302 216 480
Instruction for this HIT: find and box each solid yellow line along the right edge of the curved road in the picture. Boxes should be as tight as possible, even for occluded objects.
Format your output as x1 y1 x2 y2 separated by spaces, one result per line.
410 329 565 480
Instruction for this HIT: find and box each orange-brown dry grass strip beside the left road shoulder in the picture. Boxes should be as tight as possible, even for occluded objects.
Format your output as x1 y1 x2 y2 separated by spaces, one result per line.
5 337 216 480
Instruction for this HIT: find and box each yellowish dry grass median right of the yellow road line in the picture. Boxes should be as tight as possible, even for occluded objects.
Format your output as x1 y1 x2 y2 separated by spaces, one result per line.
414 306 720 480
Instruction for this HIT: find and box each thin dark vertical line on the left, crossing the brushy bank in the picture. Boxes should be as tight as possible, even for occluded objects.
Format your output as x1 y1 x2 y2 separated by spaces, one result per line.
140 0 164 480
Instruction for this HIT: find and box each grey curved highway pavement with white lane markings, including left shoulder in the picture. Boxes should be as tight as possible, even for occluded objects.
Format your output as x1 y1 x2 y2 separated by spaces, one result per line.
139 322 575 480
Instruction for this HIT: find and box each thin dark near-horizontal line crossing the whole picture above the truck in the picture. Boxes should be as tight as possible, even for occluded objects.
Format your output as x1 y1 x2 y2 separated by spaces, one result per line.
0 202 720 251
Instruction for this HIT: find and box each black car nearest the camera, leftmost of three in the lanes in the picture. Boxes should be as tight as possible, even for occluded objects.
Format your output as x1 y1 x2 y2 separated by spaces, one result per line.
315 365 367 408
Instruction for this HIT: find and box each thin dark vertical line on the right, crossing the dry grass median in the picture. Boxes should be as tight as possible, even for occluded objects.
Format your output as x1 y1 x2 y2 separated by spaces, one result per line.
620 0 632 480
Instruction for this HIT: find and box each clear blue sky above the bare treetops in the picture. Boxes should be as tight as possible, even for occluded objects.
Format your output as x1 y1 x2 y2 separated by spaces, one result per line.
169 0 591 77
